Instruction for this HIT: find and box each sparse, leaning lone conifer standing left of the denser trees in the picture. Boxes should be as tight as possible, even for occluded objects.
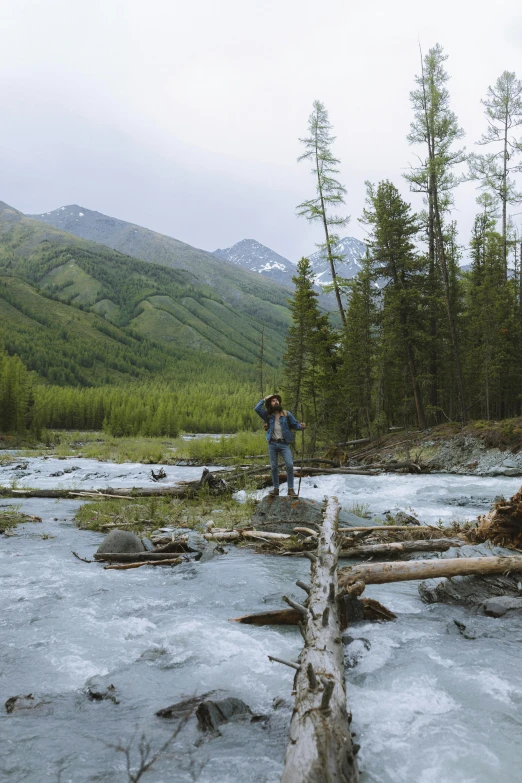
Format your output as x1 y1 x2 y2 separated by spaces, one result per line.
297 101 349 325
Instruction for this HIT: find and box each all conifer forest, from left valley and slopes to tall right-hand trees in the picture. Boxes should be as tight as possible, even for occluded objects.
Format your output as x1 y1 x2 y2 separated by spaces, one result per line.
0 44 522 448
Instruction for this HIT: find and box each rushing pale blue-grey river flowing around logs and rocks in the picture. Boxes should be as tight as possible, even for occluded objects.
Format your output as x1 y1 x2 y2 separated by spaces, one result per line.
0 458 522 783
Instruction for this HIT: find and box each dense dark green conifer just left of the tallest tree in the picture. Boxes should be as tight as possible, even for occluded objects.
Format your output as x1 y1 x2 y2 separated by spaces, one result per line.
364 180 427 429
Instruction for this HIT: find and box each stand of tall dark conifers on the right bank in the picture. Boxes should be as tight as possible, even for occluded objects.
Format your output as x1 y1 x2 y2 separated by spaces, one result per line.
284 45 522 443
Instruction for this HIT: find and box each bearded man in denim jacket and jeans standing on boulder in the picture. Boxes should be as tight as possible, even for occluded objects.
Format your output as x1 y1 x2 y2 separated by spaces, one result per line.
254 394 306 498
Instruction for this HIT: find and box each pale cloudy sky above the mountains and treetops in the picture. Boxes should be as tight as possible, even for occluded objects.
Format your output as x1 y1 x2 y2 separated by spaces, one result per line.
0 0 522 259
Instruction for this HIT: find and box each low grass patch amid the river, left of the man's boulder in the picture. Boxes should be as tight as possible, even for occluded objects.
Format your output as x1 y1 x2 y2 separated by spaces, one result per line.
75 492 255 535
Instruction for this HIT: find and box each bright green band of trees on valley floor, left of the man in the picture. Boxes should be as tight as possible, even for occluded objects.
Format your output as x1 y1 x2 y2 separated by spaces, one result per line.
0 353 258 439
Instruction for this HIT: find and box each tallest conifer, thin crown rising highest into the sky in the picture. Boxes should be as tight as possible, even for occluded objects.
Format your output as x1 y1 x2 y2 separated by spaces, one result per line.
405 44 466 424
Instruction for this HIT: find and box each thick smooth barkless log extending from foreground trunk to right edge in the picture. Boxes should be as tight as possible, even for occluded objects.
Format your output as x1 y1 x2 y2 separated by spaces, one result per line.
339 556 522 592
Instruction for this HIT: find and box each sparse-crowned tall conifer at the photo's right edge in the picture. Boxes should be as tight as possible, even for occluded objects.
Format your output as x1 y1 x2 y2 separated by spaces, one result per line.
469 71 522 278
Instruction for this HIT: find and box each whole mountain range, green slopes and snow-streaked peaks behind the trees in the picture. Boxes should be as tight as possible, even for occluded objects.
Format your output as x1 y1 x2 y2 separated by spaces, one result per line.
0 202 365 385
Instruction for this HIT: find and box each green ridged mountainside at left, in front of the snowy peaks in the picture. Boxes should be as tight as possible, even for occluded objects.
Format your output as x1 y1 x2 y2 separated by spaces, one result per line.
0 199 290 385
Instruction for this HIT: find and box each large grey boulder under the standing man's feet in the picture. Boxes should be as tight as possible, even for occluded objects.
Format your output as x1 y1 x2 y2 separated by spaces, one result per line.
248 495 372 533
